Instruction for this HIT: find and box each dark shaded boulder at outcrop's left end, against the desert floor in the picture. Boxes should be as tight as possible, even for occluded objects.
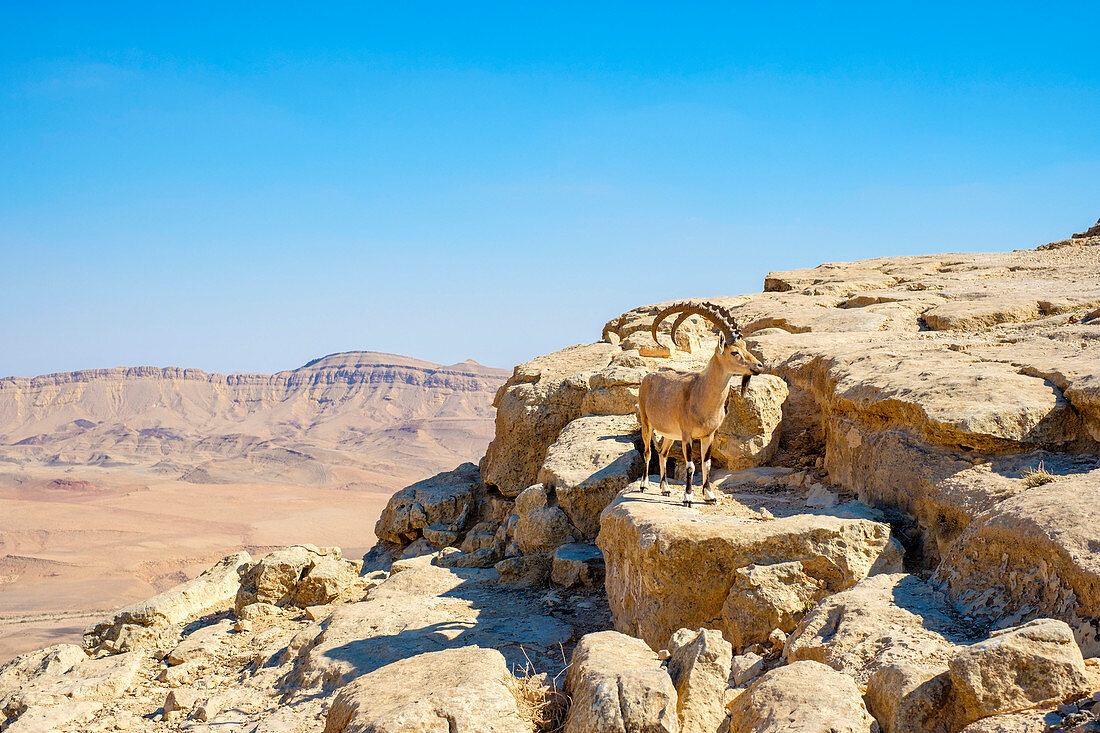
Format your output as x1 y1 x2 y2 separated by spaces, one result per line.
374 463 482 546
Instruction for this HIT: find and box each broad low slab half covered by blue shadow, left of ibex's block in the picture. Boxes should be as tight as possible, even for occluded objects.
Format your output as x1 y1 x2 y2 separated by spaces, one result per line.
289 556 573 689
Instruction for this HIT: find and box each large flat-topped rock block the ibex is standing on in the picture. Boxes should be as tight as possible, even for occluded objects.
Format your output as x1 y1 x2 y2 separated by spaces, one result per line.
596 484 901 649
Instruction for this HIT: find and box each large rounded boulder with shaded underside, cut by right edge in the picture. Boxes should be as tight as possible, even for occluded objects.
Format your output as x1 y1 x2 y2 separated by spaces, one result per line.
936 470 1100 657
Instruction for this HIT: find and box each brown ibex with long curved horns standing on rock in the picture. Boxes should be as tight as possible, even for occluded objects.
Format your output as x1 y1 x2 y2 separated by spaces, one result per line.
638 302 763 506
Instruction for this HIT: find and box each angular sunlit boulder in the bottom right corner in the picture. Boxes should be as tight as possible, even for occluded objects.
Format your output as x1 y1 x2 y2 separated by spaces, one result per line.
948 619 1090 723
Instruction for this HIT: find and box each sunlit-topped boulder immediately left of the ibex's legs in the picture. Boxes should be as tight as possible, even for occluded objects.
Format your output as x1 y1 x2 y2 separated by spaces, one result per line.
538 415 642 539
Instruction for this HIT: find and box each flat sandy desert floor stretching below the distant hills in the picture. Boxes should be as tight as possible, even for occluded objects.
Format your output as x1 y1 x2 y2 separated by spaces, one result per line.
0 467 393 663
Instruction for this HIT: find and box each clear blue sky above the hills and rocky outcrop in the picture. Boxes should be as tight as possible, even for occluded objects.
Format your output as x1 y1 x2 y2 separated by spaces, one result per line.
0 0 1100 376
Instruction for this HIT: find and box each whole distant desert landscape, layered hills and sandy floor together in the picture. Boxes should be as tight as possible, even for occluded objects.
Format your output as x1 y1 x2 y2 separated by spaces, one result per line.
0 351 506 659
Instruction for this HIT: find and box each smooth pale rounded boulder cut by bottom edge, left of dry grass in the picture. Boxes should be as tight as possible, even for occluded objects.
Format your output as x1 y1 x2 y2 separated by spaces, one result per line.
325 647 535 733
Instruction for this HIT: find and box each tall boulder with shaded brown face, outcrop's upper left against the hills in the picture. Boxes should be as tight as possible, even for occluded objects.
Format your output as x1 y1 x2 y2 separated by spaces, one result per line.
481 342 619 496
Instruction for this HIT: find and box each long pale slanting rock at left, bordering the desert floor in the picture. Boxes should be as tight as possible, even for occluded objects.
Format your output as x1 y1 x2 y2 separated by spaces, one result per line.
84 553 252 652
